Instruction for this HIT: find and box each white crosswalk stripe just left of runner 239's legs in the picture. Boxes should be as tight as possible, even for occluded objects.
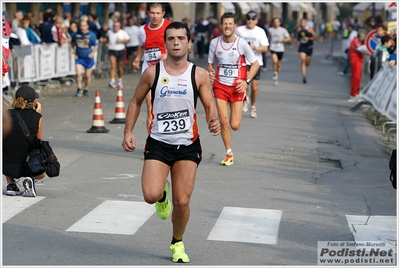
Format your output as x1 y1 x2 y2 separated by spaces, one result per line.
66 200 155 235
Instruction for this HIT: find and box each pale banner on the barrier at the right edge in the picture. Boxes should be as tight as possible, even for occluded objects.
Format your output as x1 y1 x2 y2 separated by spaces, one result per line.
360 63 397 122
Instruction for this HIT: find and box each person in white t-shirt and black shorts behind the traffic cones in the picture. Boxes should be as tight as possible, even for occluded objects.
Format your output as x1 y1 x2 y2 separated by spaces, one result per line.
107 20 130 88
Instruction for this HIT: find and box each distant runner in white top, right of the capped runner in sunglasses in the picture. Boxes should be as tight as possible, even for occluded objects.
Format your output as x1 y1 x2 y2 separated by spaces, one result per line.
269 18 292 86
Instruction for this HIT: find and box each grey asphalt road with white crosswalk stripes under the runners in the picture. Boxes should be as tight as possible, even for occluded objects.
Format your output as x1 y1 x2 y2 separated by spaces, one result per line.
2 38 397 267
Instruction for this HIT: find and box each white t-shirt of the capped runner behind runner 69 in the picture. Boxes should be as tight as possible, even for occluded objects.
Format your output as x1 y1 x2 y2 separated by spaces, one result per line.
235 25 269 66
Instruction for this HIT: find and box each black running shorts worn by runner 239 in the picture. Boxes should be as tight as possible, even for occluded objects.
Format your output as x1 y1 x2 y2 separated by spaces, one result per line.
144 136 202 166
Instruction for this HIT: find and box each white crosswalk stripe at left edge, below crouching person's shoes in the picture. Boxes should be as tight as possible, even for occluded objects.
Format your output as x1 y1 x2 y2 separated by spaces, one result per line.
2 195 46 223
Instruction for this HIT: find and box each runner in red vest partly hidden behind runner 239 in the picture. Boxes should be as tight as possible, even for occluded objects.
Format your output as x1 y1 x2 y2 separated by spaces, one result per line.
133 3 171 131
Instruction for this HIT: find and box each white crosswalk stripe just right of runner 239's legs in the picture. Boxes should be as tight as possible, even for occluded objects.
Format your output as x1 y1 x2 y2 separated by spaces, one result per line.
208 207 283 244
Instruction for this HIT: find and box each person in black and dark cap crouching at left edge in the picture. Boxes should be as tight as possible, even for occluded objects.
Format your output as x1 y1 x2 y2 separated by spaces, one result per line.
3 86 46 197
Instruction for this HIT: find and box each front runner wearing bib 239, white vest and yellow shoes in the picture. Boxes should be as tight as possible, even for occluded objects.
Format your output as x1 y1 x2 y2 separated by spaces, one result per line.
122 22 220 263
